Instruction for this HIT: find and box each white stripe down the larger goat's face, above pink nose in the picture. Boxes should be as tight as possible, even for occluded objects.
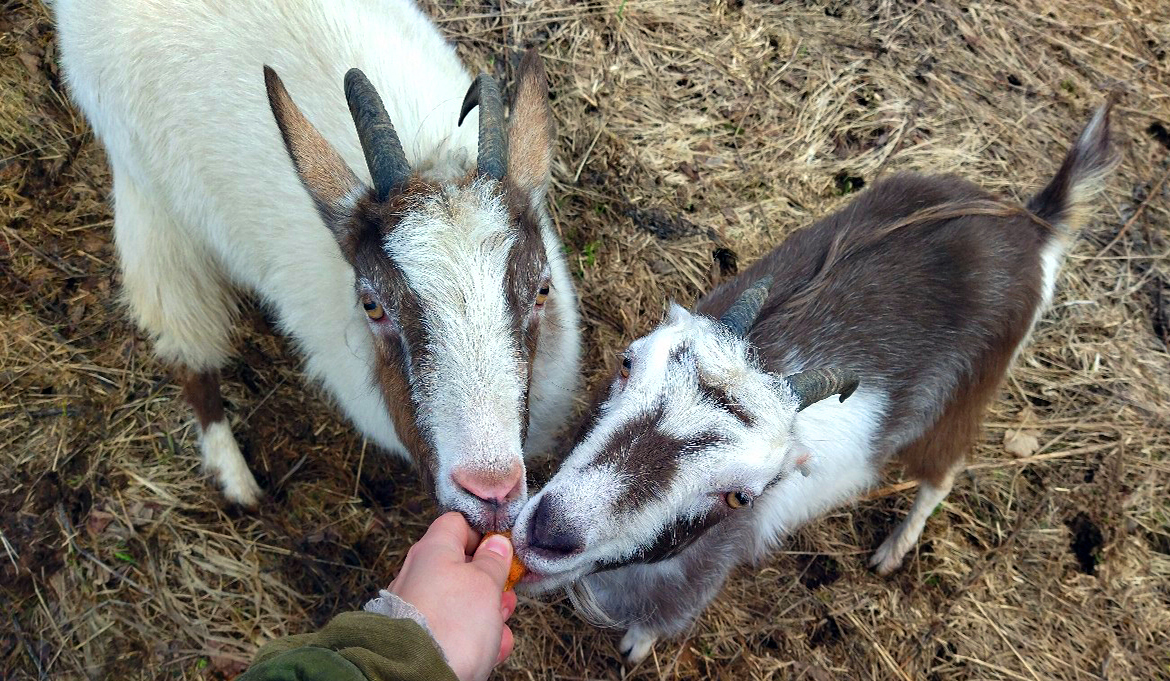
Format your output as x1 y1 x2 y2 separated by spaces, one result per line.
384 178 524 482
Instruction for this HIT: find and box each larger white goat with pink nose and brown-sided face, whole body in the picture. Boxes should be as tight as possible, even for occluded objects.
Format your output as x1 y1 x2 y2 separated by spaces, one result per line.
55 0 579 530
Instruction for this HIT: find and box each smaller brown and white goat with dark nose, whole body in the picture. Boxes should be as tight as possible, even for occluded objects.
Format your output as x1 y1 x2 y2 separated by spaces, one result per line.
512 104 1114 662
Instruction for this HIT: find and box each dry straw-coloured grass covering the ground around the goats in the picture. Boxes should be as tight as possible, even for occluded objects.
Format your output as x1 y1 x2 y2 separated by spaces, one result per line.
0 0 1170 681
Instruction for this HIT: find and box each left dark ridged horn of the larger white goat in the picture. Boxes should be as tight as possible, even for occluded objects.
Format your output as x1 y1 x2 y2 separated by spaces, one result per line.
345 69 411 201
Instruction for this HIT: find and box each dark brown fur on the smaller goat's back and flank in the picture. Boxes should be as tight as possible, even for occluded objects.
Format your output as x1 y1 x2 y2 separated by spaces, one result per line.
696 176 1054 482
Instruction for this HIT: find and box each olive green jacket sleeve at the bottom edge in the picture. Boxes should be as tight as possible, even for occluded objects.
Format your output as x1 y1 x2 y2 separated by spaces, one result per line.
238 612 459 681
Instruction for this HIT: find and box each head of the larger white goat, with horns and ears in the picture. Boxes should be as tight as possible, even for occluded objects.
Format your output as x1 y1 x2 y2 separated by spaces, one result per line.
266 53 559 531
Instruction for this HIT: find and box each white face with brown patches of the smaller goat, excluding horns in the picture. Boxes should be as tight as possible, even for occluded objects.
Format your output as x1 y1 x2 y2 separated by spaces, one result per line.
512 304 848 591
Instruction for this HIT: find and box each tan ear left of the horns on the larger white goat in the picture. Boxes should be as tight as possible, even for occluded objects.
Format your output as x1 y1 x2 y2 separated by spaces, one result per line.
264 66 367 227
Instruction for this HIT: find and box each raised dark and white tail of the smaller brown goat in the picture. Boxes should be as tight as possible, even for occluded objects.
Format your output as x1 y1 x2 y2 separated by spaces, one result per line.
1027 96 1119 233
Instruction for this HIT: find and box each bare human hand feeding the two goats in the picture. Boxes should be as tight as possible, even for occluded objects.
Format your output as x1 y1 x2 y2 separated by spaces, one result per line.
390 511 516 681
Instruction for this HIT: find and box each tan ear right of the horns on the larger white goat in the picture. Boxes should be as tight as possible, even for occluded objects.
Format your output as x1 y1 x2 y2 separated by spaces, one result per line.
508 48 555 200
